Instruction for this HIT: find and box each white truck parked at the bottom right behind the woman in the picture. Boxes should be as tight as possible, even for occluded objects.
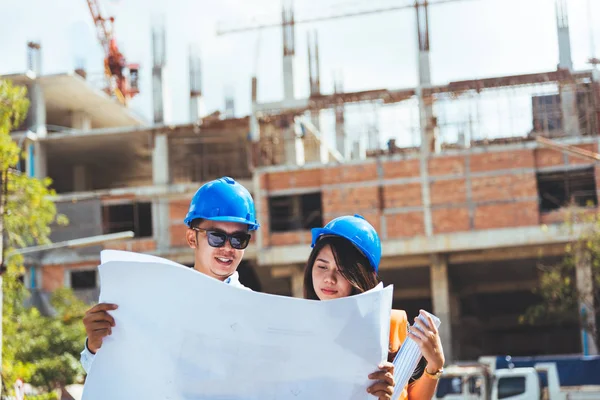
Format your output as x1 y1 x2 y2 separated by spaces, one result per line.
434 357 600 400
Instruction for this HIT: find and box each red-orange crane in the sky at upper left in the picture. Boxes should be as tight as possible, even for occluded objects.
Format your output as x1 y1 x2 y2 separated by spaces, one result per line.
86 0 140 105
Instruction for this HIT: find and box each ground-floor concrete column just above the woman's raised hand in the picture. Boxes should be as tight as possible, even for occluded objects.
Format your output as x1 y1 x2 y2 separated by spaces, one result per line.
430 254 454 363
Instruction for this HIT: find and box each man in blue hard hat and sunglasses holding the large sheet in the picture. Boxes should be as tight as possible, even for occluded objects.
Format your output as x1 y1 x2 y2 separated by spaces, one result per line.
81 177 260 373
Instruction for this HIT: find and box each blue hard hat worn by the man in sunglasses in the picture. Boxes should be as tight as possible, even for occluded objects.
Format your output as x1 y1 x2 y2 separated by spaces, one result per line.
183 176 260 231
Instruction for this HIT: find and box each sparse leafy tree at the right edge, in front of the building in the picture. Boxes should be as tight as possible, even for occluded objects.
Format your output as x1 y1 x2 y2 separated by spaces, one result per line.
521 208 600 352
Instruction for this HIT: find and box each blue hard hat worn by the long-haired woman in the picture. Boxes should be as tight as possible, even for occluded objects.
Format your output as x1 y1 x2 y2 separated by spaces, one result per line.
311 214 381 272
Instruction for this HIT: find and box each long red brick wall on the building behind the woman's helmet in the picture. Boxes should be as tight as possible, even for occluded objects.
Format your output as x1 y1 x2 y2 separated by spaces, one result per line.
259 144 600 246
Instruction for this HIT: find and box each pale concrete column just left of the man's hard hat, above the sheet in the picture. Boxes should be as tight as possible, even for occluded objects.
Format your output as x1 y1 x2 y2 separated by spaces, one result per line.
152 133 171 250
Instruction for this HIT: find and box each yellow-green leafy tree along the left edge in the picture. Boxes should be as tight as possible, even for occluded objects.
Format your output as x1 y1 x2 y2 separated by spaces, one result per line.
0 80 85 392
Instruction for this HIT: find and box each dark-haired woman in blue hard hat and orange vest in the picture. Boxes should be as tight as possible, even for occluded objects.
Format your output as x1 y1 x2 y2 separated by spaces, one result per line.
304 215 445 400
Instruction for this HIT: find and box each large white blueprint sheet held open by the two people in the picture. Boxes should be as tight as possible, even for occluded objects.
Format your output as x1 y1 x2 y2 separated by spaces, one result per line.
83 251 393 400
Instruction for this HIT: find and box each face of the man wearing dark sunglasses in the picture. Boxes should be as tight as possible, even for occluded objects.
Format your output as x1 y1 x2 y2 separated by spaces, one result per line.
186 220 248 281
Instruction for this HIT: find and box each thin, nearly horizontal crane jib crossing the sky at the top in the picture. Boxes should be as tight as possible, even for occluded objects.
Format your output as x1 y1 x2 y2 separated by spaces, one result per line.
217 0 473 36
